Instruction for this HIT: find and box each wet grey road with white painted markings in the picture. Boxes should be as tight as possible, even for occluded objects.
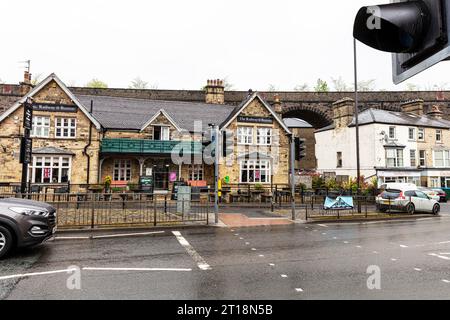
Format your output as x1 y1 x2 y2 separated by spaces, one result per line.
0 205 450 300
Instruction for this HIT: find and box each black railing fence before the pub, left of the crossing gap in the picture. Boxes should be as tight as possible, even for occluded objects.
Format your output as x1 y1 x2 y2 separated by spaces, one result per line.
0 193 213 228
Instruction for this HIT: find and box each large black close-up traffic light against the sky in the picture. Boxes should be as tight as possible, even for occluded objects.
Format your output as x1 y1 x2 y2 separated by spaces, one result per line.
353 0 450 84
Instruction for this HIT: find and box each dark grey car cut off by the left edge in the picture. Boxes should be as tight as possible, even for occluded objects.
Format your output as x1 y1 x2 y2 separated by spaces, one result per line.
0 198 56 258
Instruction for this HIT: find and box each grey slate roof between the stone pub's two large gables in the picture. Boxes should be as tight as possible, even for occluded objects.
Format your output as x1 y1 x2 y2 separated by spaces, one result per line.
76 95 239 131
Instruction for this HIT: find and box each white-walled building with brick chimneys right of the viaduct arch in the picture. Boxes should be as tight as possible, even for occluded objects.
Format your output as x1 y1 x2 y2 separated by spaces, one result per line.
315 99 450 187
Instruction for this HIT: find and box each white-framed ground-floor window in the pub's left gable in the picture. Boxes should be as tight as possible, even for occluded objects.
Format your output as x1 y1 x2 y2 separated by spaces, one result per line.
31 156 72 183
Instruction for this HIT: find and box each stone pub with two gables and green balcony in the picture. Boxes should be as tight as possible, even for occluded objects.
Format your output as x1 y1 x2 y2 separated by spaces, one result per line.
0 74 290 191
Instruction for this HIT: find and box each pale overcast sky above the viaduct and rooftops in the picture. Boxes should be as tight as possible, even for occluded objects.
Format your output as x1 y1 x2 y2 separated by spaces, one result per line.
0 0 450 90
